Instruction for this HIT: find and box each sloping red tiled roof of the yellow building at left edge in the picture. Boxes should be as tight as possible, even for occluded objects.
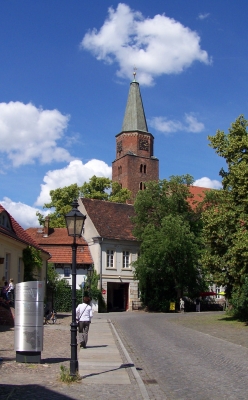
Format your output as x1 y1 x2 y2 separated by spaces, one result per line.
0 204 50 251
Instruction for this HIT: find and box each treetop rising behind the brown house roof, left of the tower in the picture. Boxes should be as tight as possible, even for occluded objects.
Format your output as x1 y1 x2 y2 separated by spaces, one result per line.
36 175 131 228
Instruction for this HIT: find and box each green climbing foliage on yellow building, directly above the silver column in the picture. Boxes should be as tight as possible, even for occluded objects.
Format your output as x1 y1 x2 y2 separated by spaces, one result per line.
22 246 42 282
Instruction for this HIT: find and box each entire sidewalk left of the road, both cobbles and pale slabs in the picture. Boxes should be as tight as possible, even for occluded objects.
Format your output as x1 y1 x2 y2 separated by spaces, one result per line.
0 313 149 400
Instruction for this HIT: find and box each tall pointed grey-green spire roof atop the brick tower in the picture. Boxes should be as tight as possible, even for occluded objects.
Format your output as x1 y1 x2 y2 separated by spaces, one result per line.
122 80 148 132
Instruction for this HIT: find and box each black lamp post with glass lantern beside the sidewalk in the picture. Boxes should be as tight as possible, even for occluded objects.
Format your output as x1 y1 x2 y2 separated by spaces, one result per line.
65 199 86 376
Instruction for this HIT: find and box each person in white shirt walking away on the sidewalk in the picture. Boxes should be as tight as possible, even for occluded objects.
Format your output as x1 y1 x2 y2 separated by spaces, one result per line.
76 296 93 348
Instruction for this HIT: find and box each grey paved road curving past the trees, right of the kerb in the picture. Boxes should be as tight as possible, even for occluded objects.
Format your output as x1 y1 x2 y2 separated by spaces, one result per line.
112 312 248 400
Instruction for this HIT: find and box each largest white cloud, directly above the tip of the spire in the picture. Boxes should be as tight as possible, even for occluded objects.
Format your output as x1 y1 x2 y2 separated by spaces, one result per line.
81 3 211 85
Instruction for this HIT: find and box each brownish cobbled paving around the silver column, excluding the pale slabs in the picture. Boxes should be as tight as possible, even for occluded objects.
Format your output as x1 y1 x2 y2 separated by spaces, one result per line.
0 314 142 400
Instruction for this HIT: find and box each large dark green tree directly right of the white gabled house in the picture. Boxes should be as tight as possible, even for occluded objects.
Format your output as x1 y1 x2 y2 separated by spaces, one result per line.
133 175 202 311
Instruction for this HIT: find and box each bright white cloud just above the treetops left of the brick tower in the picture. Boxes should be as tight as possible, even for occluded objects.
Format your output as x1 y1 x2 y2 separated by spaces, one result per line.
35 159 112 206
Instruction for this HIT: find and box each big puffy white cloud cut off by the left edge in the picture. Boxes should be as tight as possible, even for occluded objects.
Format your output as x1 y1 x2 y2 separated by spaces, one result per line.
0 101 72 167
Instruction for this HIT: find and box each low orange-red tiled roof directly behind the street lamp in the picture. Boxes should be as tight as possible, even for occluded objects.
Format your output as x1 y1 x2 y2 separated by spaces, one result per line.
27 228 93 264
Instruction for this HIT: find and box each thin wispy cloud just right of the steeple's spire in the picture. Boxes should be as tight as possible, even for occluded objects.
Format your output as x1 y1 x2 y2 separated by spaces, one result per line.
149 113 205 133
